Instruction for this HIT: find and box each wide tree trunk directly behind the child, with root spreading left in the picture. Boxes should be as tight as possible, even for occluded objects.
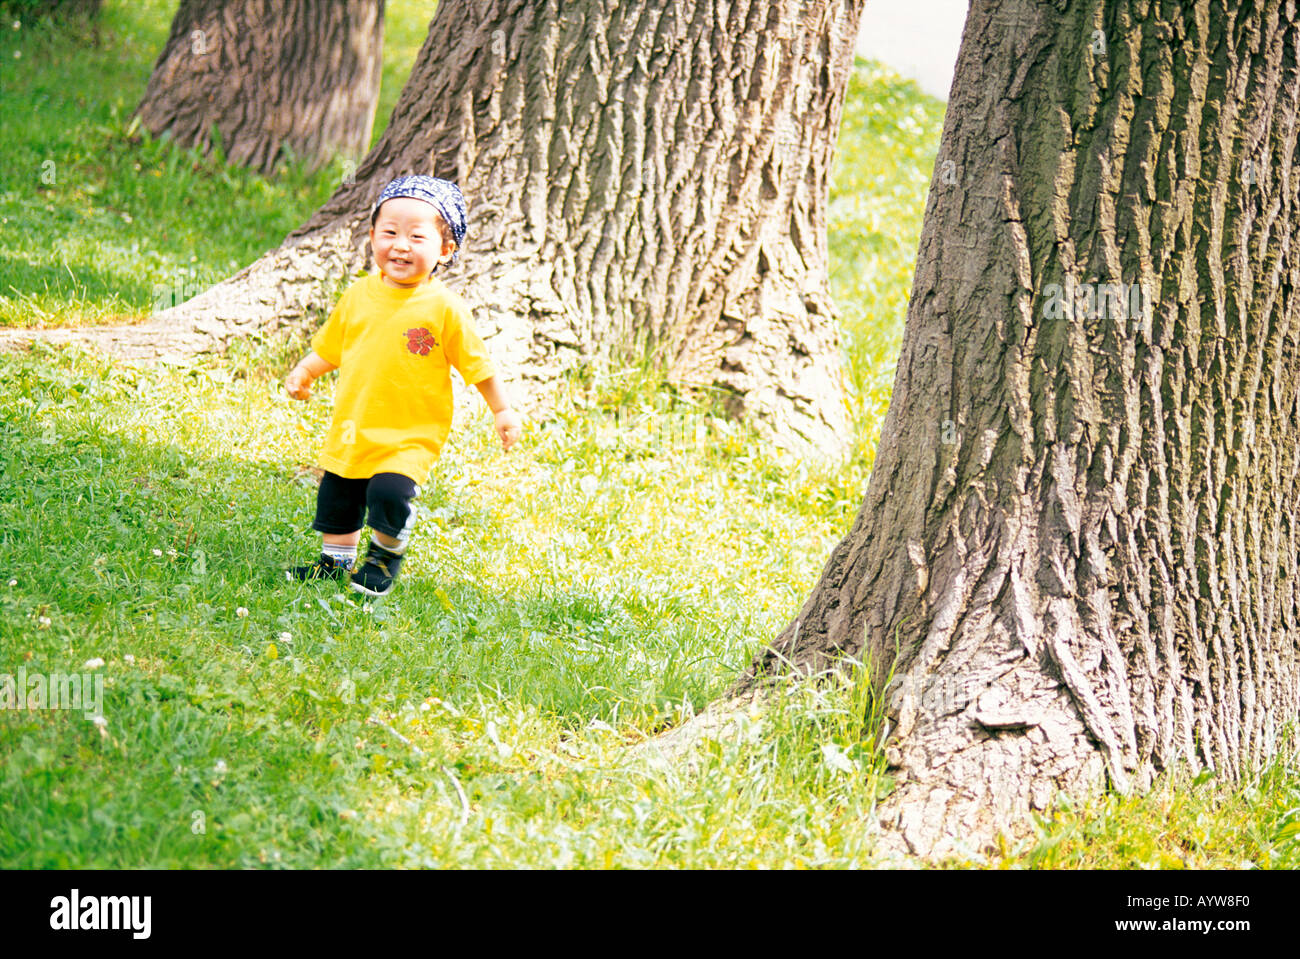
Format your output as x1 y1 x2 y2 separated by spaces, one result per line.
45 0 862 451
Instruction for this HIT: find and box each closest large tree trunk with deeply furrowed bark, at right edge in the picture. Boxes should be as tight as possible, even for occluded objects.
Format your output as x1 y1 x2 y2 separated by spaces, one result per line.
748 0 1300 855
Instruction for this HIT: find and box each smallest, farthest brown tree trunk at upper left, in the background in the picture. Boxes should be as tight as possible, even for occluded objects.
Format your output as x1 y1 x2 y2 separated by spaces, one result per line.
137 0 384 174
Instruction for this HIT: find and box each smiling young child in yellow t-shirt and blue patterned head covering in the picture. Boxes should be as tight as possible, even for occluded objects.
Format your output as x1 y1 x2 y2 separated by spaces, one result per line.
285 177 521 596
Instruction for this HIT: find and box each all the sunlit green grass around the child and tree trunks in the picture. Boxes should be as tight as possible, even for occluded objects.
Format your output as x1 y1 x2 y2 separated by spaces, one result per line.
0 1 1300 868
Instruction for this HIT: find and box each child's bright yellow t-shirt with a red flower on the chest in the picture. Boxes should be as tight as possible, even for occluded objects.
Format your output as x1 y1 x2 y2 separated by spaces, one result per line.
312 273 495 485
